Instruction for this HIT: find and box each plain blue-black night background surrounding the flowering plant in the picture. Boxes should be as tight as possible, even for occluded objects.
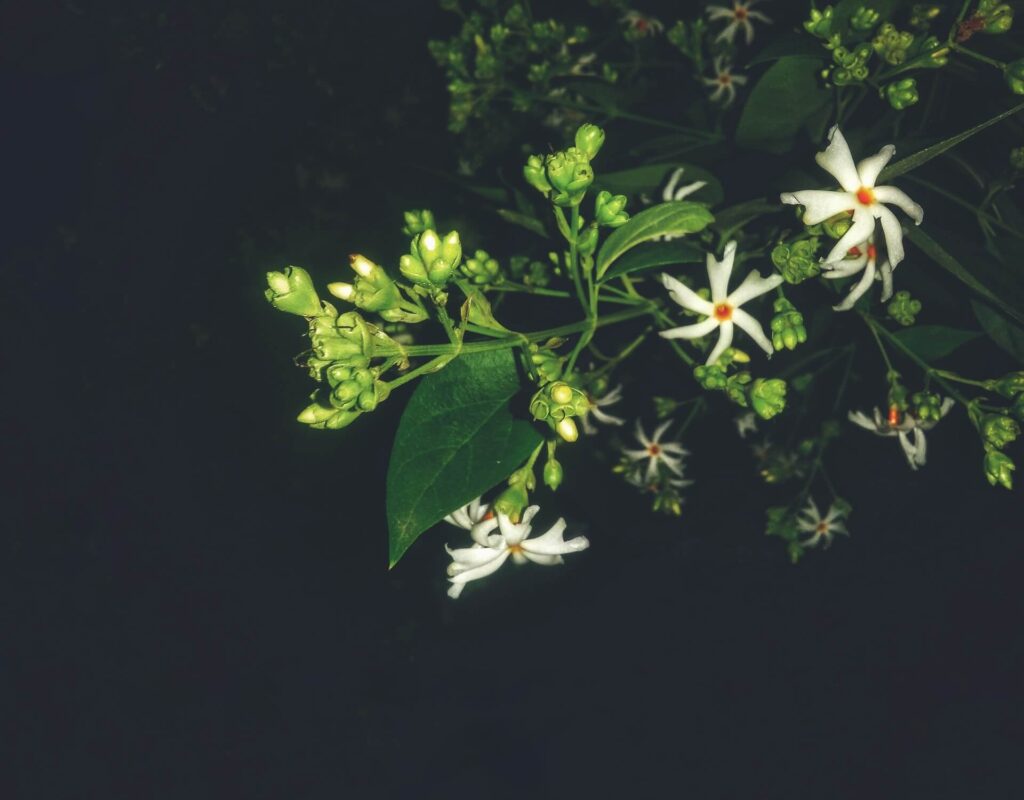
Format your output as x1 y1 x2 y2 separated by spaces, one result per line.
0 0 1024 800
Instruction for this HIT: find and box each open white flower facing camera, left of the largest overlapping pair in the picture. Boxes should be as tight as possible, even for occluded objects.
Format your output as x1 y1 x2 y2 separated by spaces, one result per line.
660 242 782 364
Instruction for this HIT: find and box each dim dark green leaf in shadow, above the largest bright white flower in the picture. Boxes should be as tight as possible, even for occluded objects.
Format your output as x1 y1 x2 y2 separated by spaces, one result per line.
736 55 830 153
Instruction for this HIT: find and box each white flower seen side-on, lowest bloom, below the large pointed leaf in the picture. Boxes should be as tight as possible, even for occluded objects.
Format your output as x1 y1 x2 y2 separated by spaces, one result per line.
444 506 590 598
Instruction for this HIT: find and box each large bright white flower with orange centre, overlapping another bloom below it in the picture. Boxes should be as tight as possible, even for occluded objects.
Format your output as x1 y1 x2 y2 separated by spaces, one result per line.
780 125 925 269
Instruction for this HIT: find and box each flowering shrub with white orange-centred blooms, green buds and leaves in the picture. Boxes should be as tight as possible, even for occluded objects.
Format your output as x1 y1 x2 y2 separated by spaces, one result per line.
266 0 1024 598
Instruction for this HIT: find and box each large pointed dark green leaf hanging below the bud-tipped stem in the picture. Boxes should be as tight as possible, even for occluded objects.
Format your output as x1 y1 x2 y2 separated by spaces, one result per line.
387 349 542 566
